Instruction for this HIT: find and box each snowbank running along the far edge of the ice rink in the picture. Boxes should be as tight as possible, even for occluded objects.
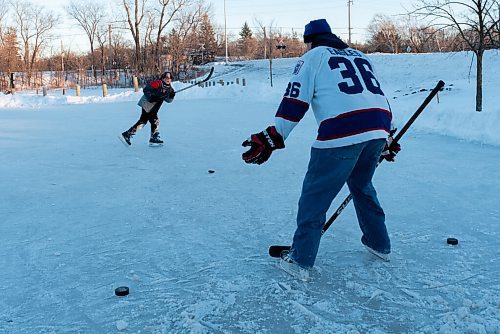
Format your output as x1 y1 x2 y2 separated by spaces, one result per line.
0 50 500 145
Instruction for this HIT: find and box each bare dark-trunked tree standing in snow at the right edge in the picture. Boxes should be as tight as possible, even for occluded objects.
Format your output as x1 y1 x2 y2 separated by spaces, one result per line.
412 0 500 111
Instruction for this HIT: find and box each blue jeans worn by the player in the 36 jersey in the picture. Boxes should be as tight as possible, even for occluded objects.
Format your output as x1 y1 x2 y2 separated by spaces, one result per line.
290 139 391 268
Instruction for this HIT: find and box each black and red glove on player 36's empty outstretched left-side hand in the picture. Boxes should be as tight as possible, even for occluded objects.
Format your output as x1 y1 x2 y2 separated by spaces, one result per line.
241 126 285 165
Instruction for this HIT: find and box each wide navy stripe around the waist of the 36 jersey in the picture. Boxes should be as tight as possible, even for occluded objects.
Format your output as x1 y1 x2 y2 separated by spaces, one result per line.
316 108 392 141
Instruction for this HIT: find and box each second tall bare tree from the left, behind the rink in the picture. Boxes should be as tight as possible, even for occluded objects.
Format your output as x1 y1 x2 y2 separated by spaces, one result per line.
66 0 106 82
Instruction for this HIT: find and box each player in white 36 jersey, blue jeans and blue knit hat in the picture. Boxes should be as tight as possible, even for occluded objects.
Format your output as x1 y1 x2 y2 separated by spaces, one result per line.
242 19 400 280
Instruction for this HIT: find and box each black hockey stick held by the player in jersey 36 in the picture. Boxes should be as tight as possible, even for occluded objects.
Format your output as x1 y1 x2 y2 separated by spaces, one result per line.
269 80 444 257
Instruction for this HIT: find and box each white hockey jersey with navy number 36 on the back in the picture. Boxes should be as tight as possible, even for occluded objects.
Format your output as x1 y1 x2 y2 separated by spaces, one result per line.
275 46 392 148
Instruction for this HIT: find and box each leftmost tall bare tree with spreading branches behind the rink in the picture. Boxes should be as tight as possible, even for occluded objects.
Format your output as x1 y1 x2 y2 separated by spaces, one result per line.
11 0 58 84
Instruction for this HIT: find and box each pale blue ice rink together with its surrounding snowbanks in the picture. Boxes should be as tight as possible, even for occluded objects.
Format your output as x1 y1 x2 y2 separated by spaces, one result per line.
0 51 500 334
